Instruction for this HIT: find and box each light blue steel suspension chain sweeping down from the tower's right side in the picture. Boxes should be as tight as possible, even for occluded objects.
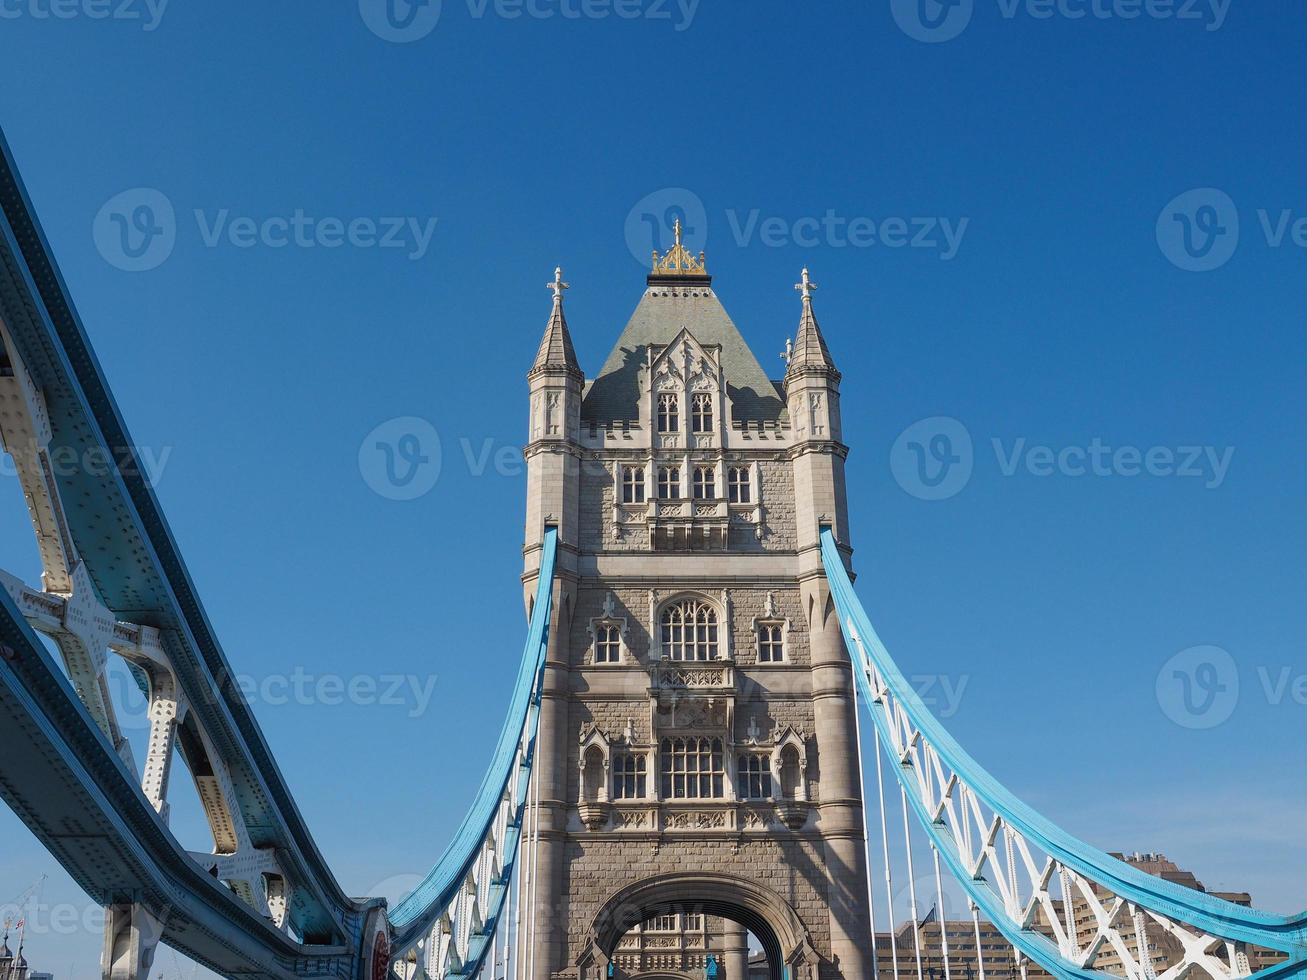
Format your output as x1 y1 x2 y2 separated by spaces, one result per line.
821 528 1307 980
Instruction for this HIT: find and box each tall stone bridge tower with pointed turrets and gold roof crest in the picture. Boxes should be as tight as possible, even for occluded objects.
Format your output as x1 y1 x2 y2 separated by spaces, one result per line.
524 230 872 980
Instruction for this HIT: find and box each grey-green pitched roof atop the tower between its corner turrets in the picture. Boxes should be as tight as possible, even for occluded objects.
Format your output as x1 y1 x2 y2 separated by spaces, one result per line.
582 285 784 422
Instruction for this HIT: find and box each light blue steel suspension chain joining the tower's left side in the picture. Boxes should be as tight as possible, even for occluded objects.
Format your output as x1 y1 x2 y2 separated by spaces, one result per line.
389 528 558 976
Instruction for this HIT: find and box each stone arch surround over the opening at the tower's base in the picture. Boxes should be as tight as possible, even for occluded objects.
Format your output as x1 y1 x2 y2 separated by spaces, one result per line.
576 872 819 980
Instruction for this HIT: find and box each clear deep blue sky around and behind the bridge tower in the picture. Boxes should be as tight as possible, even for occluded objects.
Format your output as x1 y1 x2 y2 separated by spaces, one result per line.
0 0 1307 977
